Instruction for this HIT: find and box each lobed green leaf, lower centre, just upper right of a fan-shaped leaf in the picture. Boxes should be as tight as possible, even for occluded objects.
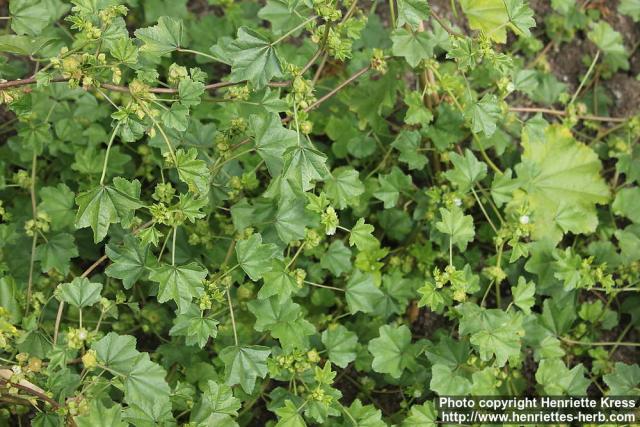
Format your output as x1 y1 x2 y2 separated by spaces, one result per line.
247 295 316 351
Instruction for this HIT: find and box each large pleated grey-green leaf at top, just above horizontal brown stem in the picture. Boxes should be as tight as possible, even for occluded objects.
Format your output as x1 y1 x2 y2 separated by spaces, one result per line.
229 27 283 88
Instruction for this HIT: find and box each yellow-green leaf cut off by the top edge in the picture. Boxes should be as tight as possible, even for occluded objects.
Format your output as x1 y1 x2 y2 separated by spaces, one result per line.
460 0 509 43
